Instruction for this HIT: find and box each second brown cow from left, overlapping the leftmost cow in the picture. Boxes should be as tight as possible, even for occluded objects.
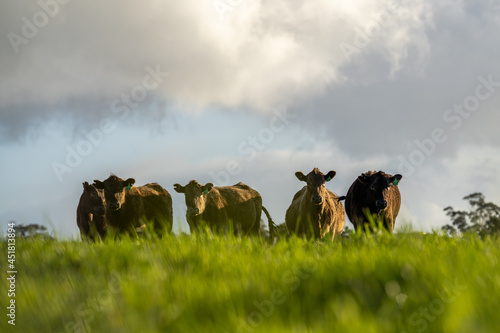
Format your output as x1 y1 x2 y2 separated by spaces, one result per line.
94 174 174 235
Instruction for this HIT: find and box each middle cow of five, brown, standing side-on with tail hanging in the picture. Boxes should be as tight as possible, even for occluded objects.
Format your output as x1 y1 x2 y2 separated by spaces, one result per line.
174 180 275 235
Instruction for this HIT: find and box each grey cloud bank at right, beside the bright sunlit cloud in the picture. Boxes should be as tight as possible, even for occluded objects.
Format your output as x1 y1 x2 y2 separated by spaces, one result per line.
293 2 500 159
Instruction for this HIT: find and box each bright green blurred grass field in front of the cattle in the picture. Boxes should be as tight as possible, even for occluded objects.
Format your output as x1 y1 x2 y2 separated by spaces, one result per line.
0 228 500 333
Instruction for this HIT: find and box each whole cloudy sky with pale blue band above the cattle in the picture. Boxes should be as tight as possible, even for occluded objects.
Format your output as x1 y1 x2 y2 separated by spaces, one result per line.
0 0 500 239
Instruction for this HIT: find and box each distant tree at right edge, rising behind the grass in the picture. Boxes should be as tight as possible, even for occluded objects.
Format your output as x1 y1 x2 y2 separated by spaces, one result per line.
441 192 500 237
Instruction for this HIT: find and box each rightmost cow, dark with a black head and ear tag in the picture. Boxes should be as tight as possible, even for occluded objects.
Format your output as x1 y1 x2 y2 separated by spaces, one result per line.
341 171 403 232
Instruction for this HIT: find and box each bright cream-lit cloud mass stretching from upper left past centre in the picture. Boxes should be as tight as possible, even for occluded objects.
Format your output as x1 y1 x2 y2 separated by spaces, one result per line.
0 0 438 138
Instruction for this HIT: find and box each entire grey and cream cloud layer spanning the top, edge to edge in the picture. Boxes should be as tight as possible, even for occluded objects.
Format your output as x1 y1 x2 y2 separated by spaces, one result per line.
0 0 500 165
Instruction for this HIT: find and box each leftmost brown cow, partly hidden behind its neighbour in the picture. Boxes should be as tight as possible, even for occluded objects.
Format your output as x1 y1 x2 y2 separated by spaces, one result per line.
76 182 108 240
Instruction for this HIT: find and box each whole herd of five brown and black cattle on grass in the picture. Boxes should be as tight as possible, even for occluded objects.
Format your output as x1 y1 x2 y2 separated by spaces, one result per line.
77 168 402 239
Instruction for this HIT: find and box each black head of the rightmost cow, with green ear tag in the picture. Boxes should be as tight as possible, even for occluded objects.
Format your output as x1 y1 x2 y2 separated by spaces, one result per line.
358 171 403 213
